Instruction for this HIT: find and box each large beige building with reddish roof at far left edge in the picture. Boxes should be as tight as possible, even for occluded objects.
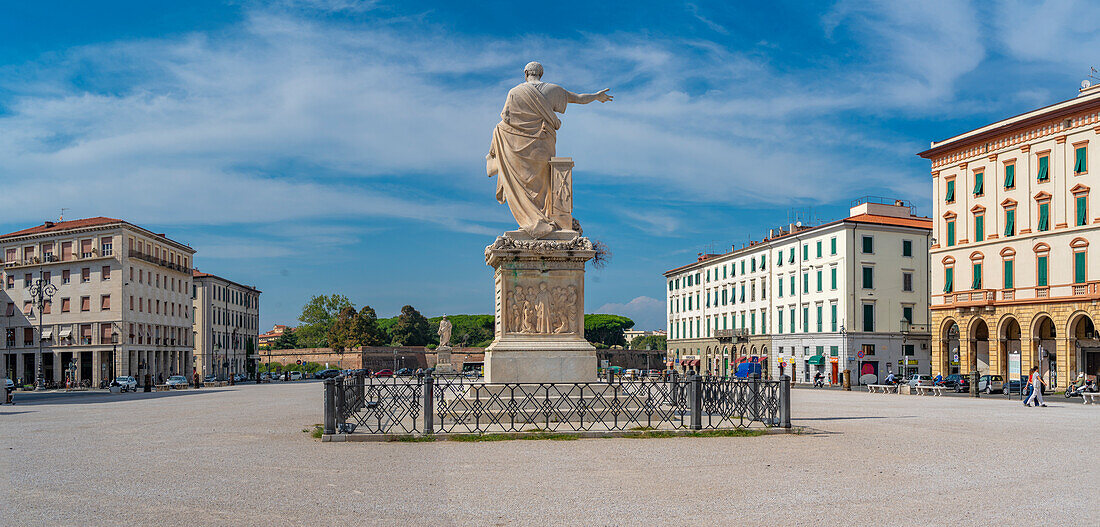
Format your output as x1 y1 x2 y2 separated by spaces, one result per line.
0 218 195 384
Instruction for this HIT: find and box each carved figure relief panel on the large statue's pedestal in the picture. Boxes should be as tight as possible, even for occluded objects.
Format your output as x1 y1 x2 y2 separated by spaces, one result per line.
505 282 579 334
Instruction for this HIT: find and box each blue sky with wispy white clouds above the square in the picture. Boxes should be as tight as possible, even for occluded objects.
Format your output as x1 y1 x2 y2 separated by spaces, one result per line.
0 0 1100 329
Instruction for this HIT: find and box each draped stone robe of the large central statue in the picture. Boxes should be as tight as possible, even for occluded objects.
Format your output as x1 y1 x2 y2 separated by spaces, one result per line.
490 83 572 238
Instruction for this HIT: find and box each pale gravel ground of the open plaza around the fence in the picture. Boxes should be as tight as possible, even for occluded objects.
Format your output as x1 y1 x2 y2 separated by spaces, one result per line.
0 382 1100 526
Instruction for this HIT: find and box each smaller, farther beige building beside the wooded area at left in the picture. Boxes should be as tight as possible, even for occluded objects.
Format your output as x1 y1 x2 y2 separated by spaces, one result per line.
191 270 260 378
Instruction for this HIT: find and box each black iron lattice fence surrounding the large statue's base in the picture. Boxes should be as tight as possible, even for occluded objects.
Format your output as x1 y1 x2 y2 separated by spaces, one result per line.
325 374 791 435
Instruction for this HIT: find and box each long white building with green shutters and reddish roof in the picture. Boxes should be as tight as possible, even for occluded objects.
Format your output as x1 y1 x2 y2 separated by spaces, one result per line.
664 199 932 382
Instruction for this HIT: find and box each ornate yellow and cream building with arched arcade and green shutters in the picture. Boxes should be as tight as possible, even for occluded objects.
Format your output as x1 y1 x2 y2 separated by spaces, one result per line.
920 81 1100 386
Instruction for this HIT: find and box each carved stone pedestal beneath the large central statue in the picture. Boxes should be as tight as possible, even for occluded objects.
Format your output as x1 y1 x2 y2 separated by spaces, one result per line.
485 230 596 383
